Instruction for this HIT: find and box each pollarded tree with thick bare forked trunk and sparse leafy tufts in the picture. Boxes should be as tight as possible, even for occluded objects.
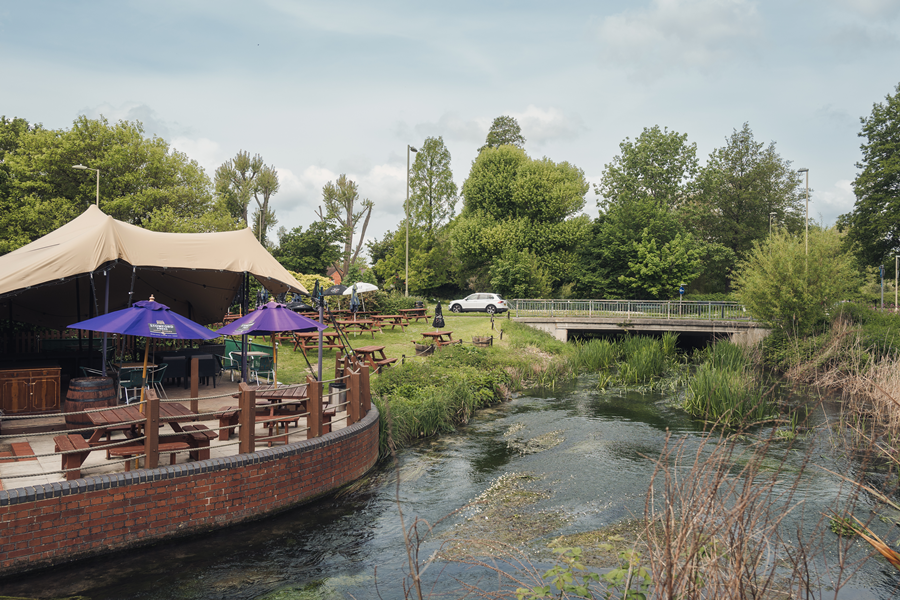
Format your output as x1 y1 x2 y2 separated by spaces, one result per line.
317 174 373 277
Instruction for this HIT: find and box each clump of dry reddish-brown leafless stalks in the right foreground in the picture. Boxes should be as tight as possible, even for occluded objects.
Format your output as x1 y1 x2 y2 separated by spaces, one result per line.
645 428 860 600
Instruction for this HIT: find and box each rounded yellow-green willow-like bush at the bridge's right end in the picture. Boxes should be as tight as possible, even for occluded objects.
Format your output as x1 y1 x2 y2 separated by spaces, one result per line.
734 228 861 335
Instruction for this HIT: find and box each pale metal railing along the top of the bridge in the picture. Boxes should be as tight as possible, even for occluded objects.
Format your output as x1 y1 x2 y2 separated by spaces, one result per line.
508 298 750 321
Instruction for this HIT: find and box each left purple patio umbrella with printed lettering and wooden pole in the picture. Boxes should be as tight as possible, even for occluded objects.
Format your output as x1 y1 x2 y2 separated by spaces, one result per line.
69 296 219 402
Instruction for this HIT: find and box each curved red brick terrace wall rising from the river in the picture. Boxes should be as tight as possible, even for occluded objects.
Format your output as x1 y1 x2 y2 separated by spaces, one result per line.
0 407 378 575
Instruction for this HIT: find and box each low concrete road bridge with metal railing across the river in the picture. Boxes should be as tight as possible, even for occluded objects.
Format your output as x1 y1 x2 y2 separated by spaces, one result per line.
509 299 768 343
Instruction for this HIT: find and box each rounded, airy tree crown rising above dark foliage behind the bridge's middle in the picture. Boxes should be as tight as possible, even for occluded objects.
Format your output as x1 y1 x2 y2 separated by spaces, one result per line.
594 125 698 208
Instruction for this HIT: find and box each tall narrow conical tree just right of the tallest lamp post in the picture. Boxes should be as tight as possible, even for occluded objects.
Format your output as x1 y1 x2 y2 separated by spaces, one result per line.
409 136 457 232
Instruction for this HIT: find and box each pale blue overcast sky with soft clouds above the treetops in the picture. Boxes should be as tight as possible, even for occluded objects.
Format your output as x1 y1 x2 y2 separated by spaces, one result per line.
0 0 900 253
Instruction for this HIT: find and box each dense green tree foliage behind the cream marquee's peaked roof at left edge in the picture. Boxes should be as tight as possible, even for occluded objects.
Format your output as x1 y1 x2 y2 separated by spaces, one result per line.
0 116 235 253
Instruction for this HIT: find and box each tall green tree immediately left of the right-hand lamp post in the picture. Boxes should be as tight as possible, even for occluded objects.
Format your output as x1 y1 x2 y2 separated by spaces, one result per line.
683 123 804 257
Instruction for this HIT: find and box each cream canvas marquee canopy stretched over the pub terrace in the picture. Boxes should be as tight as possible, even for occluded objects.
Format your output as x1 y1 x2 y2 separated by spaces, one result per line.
0 205 307 328
